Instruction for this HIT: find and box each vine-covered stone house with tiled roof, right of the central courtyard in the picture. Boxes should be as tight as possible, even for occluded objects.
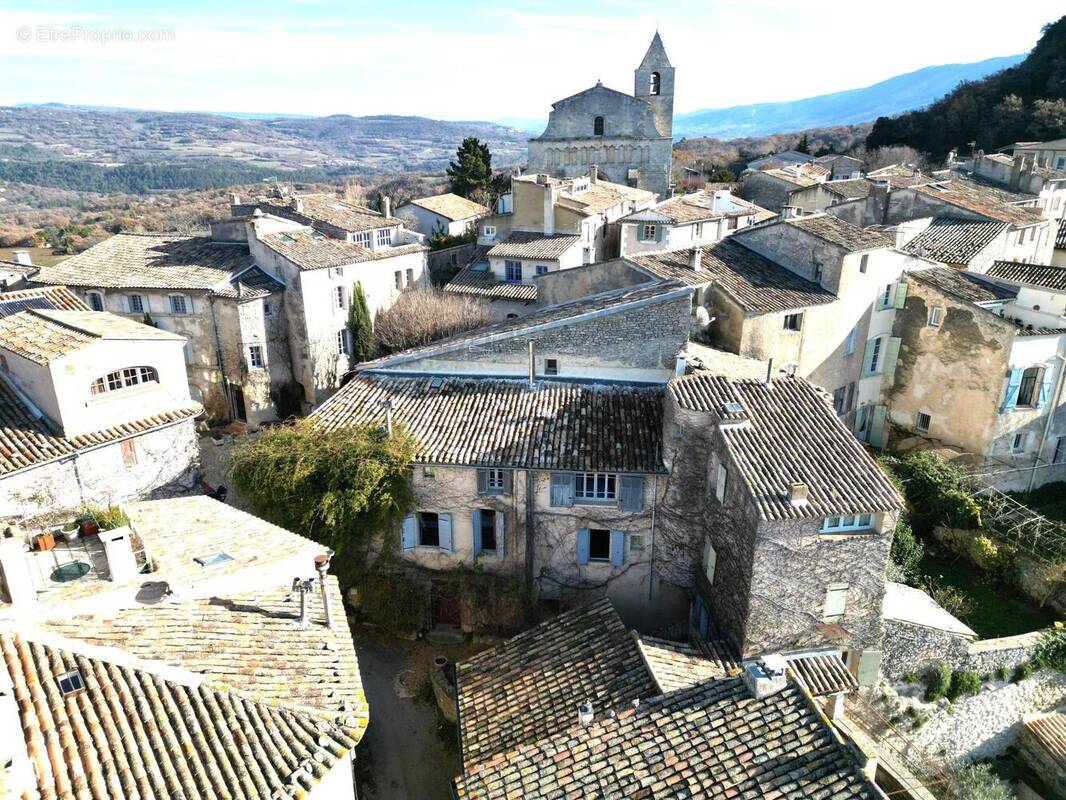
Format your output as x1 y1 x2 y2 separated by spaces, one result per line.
663 371 903 665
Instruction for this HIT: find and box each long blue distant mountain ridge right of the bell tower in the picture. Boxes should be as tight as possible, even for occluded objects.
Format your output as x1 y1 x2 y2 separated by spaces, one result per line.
674 55 1024 139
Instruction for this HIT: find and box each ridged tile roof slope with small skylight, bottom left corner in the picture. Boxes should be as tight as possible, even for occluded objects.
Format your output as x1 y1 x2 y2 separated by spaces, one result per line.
0 631 356 800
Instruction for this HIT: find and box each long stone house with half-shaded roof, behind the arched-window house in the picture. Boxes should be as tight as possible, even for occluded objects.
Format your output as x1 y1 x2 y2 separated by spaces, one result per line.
33 234 292 425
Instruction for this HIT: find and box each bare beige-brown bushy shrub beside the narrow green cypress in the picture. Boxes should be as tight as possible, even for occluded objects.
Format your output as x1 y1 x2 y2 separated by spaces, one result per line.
374 288 489 354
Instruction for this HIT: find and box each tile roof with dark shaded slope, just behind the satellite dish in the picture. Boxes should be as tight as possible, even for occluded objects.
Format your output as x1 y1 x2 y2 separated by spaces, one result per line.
628 235 836 314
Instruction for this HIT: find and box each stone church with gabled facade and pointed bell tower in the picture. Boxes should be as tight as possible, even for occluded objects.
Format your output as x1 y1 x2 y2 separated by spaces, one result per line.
529 31 674 199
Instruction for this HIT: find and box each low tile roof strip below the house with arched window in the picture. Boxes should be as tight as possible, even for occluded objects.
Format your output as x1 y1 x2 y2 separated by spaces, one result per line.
0 377 204 476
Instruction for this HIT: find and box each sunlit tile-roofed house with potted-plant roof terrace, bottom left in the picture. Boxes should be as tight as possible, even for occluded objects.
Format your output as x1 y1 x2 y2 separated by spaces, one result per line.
0 496 368 800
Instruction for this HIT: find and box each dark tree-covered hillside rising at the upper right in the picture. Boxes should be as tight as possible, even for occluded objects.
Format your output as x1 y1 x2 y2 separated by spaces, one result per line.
867 17 1066 157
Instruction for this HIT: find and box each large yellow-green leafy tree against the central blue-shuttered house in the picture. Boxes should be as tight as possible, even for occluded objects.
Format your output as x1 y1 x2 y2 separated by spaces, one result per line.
230 419 415 583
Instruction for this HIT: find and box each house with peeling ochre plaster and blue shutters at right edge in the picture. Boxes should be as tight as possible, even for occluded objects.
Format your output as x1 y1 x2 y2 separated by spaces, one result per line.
885 265 1066 489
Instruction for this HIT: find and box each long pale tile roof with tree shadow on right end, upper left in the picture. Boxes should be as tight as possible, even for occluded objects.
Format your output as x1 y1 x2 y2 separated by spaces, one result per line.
33 234 253 297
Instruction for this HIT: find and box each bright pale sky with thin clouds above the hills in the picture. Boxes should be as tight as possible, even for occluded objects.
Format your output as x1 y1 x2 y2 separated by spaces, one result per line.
0 0 1063 119
